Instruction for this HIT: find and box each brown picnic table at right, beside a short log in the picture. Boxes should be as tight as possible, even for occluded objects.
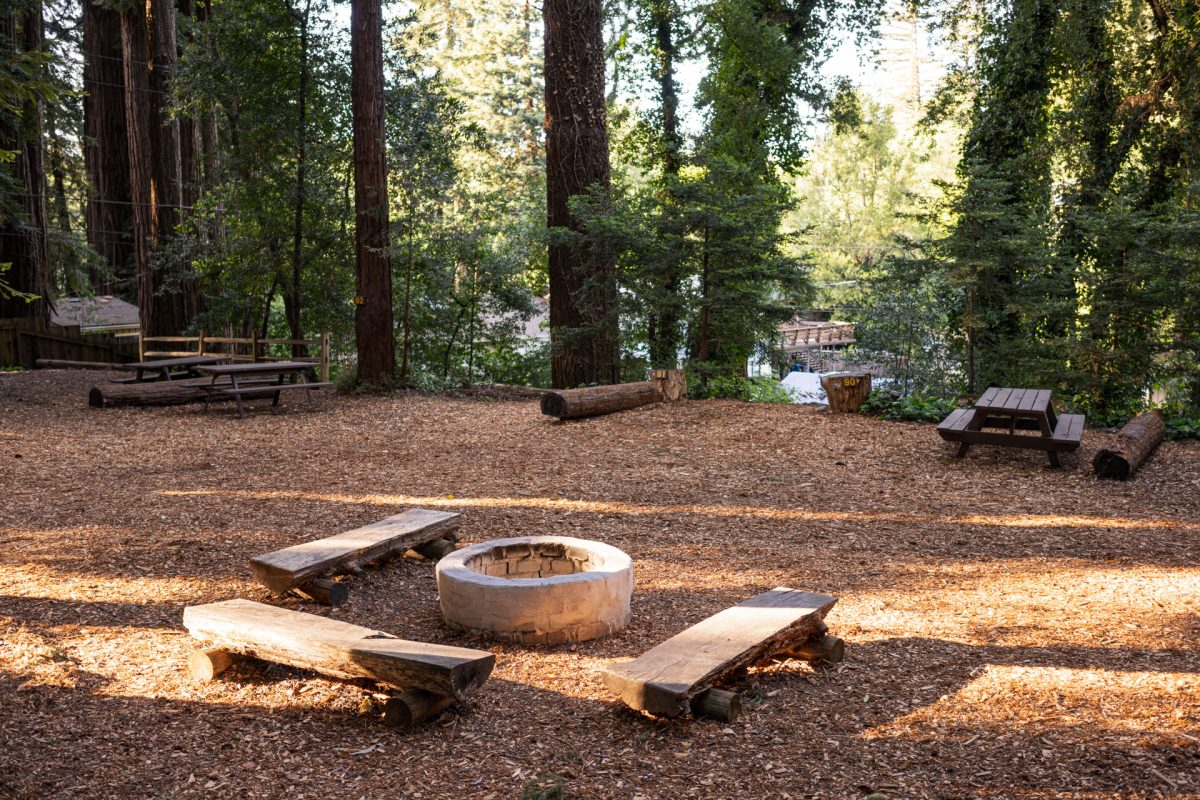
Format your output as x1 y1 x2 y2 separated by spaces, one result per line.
937 386 1084 467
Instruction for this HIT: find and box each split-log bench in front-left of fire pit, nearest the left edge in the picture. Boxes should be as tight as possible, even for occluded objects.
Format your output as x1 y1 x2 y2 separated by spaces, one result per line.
184 600 496 727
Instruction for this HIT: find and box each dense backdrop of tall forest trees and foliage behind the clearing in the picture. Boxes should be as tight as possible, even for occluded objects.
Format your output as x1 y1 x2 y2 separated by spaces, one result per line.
0 0 1200 420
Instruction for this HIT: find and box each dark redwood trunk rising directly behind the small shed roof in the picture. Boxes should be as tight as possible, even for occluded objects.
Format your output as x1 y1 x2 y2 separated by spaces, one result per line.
83 0 136 294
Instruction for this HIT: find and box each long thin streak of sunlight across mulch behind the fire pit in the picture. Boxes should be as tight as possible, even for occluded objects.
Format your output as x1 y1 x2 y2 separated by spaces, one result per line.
158 489 1200 530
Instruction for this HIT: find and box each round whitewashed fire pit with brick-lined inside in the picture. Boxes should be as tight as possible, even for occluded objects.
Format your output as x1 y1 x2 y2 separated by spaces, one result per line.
437 536 634 644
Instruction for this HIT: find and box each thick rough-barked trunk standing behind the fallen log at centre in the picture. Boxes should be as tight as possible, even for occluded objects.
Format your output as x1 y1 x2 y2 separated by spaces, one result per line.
542 0 620 389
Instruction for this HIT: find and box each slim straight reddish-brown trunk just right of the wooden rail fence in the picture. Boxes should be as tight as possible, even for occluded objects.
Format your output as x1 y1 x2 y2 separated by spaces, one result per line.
350 0 396 385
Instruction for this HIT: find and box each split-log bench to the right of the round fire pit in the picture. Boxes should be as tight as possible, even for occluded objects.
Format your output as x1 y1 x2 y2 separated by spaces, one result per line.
604 587 845 721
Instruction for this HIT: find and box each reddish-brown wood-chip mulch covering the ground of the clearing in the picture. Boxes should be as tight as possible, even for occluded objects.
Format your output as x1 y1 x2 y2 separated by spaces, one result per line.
0 372 1200 800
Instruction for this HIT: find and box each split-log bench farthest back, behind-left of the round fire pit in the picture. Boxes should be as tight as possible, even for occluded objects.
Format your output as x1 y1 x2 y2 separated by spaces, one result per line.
250 509 460 606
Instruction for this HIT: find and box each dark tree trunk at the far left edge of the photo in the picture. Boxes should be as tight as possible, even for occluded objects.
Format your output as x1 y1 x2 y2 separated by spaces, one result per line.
0 4 50 319
